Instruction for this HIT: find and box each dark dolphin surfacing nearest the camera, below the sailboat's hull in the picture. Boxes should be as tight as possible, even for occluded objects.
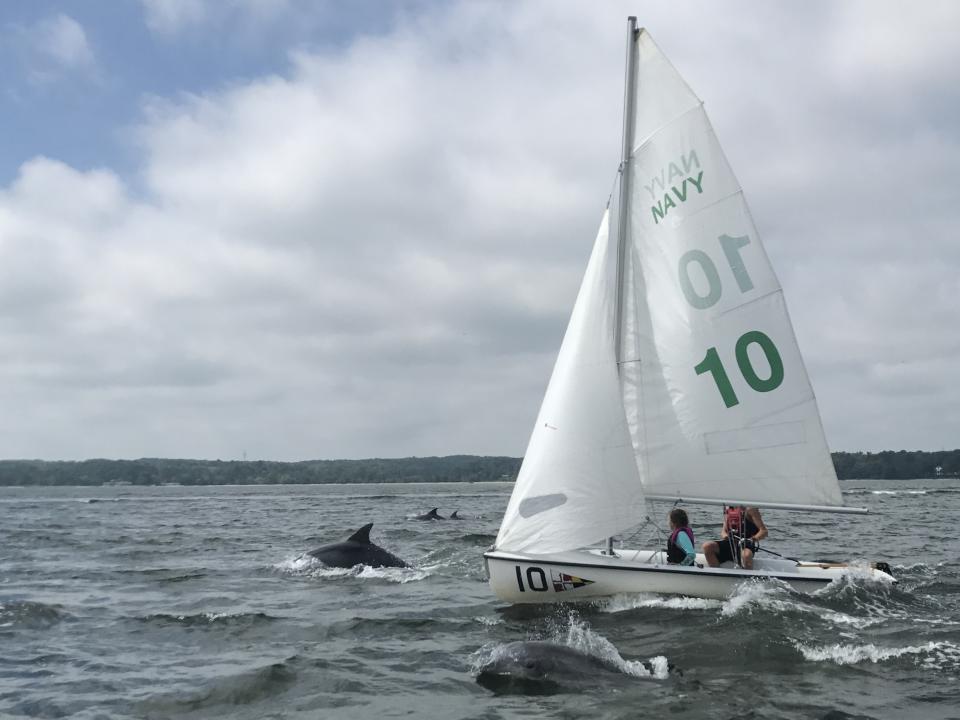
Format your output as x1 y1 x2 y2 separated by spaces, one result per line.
477 640 674 695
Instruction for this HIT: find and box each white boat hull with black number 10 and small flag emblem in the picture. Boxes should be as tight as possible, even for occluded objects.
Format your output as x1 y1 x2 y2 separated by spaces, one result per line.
483 549 895 603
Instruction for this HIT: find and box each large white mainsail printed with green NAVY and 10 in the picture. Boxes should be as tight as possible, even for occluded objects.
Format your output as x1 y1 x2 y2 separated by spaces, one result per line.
621 31 841 506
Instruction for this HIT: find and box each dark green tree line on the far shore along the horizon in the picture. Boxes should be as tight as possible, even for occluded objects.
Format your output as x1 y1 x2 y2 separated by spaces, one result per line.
0 450 960 486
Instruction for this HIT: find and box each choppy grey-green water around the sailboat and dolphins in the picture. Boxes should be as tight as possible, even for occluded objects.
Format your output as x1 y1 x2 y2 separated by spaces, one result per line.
0 480 960 719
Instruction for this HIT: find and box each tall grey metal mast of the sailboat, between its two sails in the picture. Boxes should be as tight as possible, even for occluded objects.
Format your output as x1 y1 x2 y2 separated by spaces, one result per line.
607 15 641 555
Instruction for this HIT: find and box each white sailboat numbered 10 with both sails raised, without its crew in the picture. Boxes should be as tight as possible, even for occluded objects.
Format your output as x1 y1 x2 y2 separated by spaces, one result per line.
484 17 889 603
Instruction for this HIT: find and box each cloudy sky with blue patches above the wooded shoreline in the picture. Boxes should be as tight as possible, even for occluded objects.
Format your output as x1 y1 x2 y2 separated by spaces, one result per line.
0 0 960 460
